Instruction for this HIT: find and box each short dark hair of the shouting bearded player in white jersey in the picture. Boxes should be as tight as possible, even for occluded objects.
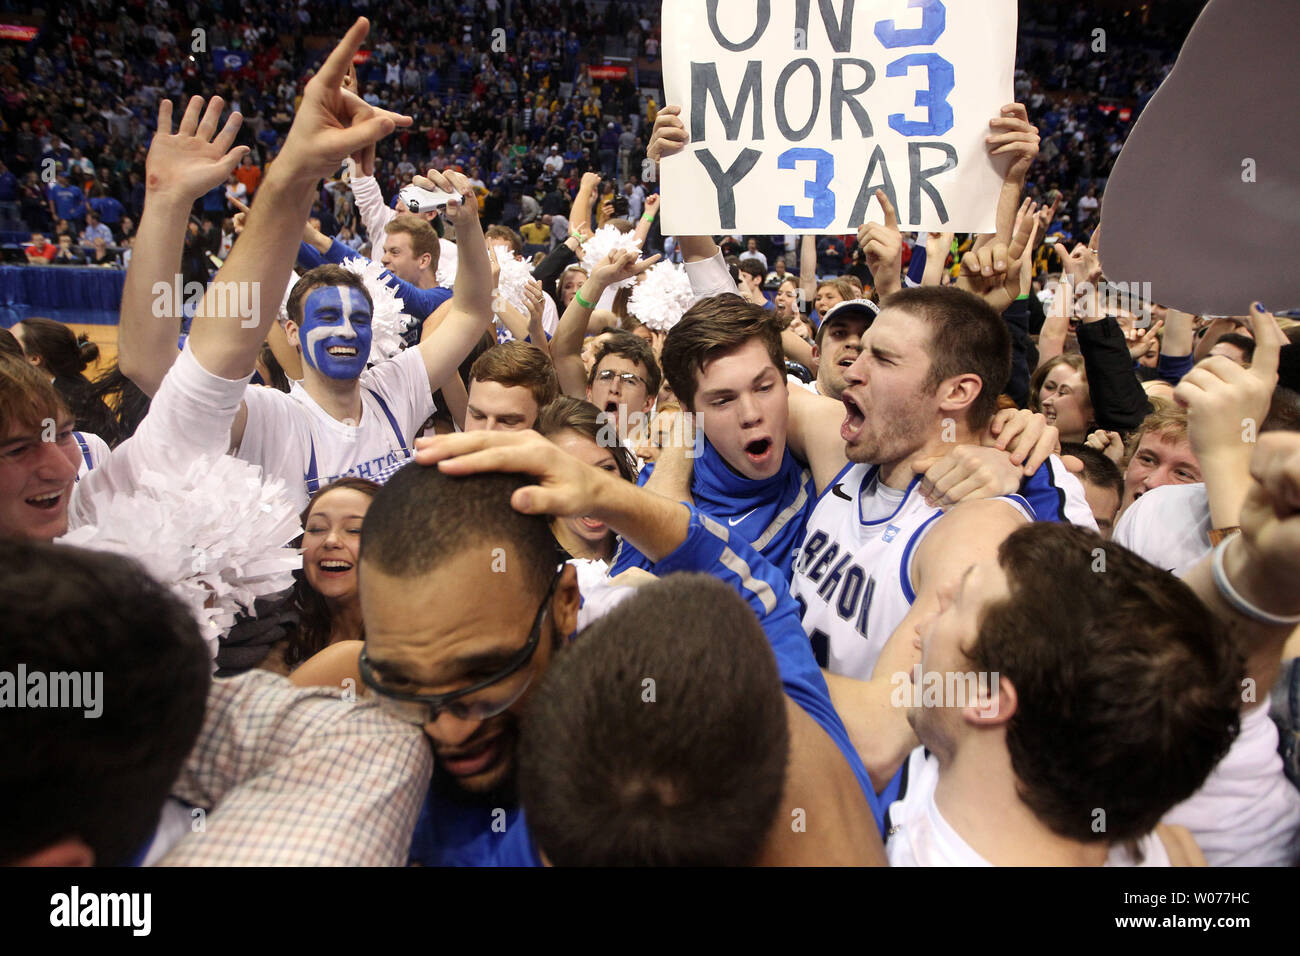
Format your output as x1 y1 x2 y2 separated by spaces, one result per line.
880 286 1011 431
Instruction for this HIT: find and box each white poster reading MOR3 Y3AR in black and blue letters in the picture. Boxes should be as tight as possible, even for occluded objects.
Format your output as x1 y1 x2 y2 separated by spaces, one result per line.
660 0 1017 235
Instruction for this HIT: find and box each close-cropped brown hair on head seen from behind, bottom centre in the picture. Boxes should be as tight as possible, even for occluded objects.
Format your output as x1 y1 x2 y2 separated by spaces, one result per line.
519 574 789 866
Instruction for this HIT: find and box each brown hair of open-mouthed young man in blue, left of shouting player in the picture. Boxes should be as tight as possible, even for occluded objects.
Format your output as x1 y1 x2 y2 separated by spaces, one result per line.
660 293 785 411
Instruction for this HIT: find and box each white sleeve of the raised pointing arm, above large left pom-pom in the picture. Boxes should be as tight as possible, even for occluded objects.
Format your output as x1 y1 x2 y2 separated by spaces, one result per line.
69 339 252 528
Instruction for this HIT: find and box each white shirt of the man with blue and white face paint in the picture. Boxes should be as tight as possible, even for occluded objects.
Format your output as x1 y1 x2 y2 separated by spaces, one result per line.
235 349 436 509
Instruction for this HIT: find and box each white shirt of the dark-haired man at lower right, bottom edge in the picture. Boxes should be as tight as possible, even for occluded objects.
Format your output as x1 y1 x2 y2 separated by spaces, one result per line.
885 747 1170 866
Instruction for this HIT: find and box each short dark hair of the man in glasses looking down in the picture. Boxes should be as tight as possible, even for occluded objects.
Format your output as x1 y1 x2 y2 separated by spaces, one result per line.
361 463 559 600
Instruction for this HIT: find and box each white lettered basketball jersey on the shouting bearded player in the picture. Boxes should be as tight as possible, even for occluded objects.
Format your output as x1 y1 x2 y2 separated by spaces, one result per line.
790 464 1036 680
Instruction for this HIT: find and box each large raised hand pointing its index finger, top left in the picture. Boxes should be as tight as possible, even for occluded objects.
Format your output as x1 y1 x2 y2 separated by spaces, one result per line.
270 17 412 185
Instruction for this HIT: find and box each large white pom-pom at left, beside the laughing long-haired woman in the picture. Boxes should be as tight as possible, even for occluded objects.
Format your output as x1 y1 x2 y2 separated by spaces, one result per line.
59 455 303 657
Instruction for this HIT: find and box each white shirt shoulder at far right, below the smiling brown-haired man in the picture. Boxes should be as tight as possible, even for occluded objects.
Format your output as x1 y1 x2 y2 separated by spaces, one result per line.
1115 484 1213 578
